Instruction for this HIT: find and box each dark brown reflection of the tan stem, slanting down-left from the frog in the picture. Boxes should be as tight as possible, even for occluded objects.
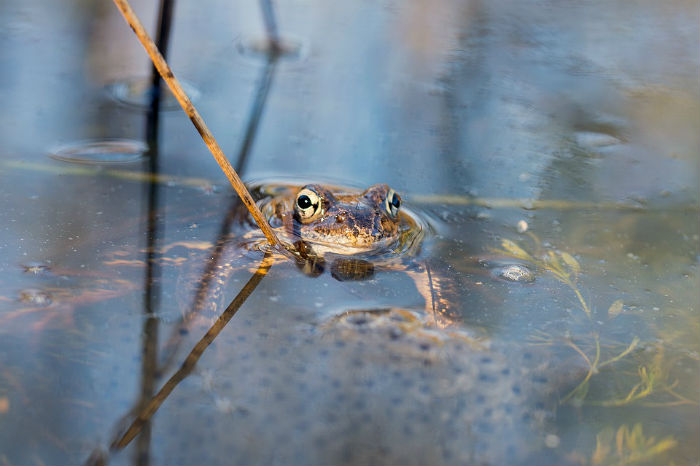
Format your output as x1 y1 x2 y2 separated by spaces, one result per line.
112 253 274 449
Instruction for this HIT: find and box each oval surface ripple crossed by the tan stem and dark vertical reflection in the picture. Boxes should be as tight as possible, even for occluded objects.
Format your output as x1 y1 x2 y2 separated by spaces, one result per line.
106 76 200 110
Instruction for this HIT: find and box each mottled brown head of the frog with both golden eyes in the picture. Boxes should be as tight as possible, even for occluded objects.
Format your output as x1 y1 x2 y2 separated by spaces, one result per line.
267 184 401 255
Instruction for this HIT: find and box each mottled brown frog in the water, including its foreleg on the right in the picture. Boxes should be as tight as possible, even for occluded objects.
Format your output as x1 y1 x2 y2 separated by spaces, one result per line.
238 183 461 328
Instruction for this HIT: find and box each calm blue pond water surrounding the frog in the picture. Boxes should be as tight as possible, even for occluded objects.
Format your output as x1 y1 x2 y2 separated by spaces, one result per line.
0 0 700 465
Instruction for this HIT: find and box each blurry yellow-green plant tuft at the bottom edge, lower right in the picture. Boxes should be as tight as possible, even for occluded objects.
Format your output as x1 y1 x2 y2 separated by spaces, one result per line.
590 423 678 466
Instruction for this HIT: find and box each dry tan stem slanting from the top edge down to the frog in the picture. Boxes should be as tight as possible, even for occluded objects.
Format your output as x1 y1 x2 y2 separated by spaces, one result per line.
114 0 280 246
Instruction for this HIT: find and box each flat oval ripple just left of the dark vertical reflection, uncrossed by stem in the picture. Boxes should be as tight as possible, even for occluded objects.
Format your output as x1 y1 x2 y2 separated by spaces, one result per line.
49 139 148 164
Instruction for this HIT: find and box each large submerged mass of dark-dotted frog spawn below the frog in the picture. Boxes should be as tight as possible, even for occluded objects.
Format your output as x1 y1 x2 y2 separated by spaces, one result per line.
163 309 568 465
